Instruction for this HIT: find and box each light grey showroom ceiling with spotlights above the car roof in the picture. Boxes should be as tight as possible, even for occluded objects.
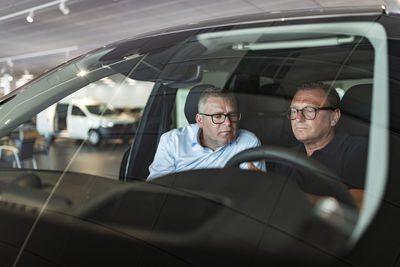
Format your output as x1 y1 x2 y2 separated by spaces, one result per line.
0 0 383 90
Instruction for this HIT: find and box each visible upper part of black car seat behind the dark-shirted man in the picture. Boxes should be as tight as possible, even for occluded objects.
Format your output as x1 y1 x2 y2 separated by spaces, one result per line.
337 84 372 136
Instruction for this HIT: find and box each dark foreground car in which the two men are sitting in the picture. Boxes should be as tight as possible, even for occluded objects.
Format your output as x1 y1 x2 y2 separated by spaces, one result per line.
0 5 400 266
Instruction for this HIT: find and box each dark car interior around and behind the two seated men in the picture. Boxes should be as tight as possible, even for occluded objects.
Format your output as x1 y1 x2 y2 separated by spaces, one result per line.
120 37 373 184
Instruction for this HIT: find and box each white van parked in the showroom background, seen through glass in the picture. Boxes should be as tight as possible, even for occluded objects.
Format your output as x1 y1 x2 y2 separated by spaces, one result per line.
36 97 139 145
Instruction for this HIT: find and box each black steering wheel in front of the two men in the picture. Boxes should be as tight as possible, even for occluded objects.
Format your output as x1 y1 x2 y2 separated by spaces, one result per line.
224 146 356 207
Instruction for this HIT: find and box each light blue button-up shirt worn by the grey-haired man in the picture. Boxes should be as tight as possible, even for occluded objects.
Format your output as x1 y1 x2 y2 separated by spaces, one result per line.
147 123 266 181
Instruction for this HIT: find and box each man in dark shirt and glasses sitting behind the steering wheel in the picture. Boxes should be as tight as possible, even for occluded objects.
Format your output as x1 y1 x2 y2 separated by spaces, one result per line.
282 82 368 209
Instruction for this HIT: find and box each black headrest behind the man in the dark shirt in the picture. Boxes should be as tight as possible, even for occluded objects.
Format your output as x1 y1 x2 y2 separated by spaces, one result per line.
341 84 372 122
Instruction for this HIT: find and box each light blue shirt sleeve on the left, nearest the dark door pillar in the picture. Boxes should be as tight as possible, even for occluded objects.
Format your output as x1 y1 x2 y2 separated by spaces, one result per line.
146 133 175 181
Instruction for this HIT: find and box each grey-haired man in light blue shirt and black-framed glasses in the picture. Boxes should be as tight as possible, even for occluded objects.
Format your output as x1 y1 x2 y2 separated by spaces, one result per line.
147 87 265 181
